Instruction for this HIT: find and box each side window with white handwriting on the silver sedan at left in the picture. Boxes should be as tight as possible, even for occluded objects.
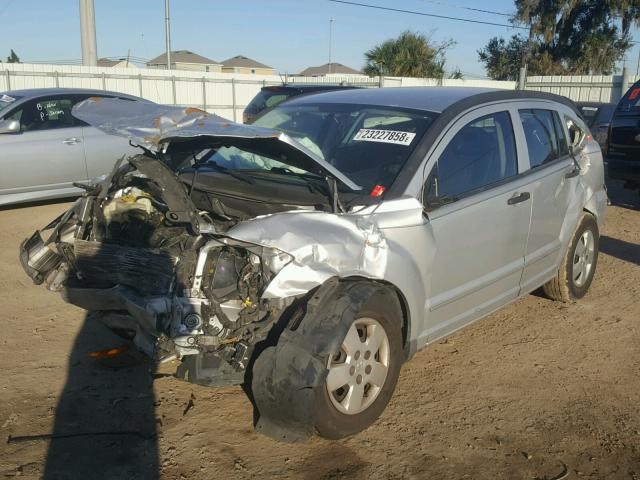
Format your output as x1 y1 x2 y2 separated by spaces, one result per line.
9 98 77 132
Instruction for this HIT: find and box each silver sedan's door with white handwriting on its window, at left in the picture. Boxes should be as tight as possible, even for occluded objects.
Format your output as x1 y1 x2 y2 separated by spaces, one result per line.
0 95 87 195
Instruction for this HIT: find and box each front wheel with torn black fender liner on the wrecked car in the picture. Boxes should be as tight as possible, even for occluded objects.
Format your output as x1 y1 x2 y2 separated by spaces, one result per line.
251 279 403 441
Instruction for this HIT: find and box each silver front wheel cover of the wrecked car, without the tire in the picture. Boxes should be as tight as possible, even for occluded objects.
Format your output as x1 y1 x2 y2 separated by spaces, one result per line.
326 317 391 415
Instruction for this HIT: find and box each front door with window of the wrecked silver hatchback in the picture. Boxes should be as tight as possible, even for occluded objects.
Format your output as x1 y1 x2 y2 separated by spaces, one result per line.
424 106 531 342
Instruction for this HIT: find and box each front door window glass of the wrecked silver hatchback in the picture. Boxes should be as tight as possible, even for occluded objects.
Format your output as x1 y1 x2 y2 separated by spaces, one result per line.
427 112 518 199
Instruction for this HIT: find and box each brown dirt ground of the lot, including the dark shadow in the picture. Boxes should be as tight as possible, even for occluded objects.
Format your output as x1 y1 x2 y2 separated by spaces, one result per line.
0 181 640 480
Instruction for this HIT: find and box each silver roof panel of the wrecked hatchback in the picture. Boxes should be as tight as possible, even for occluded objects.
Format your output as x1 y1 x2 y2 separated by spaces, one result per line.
287 87 575 113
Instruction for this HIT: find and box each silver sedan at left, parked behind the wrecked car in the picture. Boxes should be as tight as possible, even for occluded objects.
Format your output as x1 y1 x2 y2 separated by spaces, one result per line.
0 88 146 205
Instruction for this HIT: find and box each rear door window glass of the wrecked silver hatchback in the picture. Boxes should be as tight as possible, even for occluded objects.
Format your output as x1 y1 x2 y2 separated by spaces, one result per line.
519 109 568 168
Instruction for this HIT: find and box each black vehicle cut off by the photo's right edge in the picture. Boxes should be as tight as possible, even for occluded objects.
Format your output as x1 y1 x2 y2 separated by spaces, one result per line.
606 81 640 190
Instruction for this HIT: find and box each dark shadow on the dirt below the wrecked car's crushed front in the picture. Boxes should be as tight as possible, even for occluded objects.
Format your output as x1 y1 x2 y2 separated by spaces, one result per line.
43 315 159 480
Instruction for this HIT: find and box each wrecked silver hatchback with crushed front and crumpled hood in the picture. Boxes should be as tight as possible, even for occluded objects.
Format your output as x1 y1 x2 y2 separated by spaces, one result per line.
20 88 607 441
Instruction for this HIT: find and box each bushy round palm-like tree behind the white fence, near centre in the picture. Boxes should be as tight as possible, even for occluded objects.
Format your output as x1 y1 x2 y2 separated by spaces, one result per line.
362 30 454 78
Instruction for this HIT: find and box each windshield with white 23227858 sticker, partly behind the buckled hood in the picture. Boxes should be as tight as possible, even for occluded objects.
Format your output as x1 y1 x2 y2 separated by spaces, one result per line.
242 103 436 190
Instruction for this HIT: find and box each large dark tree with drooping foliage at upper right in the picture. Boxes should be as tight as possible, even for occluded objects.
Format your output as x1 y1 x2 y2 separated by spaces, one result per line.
478 0 640 79
